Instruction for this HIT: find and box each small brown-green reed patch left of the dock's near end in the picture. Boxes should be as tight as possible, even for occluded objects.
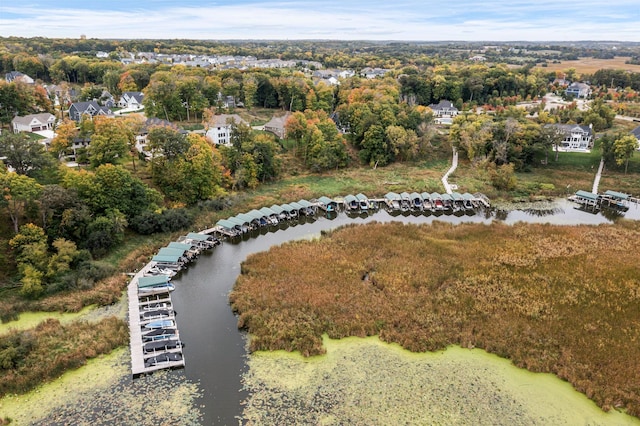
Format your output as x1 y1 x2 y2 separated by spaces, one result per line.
0 317 129 397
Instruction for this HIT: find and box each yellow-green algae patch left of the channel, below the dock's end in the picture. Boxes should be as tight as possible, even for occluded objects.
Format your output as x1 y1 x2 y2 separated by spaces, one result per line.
0 348 202 426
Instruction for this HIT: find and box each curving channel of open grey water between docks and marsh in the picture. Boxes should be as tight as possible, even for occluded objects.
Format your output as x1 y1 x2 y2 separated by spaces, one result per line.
173 200 640 425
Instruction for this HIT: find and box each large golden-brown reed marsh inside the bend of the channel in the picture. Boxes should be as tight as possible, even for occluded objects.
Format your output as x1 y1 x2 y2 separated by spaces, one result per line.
230 222 640 417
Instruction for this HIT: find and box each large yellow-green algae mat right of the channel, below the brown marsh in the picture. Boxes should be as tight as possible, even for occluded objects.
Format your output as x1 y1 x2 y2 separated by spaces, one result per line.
243 337 640 425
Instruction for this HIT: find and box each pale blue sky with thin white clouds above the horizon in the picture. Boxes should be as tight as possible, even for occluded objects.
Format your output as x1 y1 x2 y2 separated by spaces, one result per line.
0 0 640 42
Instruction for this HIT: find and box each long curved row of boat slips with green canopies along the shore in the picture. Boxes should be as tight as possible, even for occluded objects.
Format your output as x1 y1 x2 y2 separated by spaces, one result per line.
128 192 488 377
